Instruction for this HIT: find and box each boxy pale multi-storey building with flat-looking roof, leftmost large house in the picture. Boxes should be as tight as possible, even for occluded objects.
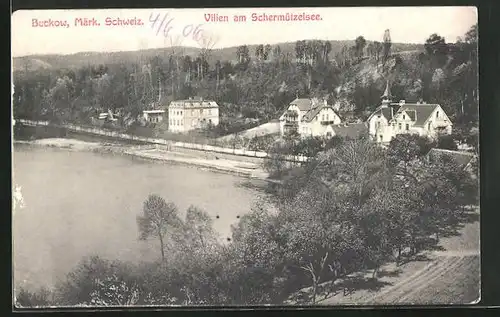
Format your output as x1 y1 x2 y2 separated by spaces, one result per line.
168 98 219 133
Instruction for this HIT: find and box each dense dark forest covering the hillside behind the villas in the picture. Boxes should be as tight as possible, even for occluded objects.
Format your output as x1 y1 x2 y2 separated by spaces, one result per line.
13 25 478 134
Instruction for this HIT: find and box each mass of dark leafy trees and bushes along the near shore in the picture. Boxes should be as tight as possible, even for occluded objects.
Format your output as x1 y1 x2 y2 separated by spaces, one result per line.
16 135 478 307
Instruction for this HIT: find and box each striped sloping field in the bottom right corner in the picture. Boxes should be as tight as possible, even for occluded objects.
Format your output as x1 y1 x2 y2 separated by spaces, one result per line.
319 209 480 305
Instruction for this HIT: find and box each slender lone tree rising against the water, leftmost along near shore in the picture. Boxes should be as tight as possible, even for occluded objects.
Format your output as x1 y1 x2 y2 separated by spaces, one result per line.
137 195 180 260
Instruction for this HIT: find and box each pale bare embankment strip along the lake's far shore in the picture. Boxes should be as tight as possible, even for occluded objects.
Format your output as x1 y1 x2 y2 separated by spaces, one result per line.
14 138 269 180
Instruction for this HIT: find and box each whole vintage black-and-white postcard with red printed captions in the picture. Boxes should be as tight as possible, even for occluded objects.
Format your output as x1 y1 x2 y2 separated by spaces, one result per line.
12 7 481 308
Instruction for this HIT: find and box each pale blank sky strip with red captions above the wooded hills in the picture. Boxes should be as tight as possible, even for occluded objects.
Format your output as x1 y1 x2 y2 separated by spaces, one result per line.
11 7 477 57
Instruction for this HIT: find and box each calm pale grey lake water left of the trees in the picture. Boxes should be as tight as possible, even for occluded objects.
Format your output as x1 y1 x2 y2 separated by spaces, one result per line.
13 145 258 287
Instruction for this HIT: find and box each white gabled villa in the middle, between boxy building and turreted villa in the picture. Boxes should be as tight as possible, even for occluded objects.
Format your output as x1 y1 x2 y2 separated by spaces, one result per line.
279 98 341 137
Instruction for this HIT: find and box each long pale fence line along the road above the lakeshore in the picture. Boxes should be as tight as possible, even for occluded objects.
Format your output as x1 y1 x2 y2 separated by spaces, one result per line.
17 119 308 162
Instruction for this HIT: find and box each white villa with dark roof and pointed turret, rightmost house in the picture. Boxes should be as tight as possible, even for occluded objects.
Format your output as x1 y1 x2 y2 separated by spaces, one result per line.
367 83 453 143
